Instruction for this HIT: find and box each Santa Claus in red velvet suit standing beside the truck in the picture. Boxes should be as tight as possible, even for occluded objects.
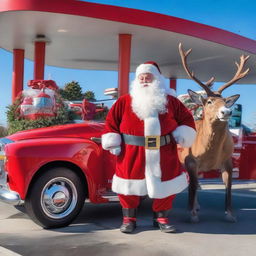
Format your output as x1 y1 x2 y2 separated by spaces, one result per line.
102 62 196 233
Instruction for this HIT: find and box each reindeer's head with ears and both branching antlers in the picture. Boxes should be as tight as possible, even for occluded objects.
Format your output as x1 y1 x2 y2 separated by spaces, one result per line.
179 43 249 121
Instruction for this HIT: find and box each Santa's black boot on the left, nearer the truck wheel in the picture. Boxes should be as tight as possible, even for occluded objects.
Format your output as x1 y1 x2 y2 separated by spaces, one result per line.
120 208 137 233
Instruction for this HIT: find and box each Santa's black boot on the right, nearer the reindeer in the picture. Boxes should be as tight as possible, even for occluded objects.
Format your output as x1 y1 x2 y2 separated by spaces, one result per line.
153 210 176 233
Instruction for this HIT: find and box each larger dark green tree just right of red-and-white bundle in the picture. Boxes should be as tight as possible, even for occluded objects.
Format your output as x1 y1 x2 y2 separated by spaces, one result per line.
59 81 83 100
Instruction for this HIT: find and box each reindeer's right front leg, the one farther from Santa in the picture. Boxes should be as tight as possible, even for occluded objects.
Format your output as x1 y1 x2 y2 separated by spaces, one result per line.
222 159 236 222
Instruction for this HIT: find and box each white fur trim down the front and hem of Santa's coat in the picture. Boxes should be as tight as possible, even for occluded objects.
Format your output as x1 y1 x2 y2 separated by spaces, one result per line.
112 110 190 198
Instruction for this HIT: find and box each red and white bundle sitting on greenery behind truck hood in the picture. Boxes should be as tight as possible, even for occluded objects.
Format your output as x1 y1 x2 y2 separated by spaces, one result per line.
20 80 58 120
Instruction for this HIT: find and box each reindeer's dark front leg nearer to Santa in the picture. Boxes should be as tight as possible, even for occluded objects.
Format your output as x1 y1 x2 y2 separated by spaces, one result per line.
185 156 200 223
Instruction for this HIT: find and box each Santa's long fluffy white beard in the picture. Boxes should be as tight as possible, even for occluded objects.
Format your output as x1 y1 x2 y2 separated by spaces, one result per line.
130 76 167 120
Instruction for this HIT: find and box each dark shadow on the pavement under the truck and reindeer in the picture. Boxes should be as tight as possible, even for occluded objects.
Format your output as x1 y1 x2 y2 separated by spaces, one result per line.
9 190 256 235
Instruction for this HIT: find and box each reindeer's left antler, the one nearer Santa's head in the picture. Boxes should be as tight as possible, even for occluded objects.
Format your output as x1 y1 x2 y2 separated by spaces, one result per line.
179 43 215 96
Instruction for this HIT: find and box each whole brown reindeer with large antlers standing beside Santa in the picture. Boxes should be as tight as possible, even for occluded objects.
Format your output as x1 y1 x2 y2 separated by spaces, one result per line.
179 43 249 222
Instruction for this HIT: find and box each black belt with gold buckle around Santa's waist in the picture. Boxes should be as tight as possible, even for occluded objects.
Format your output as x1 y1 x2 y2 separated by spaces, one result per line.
122 133 173 149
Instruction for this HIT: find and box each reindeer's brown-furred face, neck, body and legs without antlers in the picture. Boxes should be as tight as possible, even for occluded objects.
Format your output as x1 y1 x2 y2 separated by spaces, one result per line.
178 92 238 222
